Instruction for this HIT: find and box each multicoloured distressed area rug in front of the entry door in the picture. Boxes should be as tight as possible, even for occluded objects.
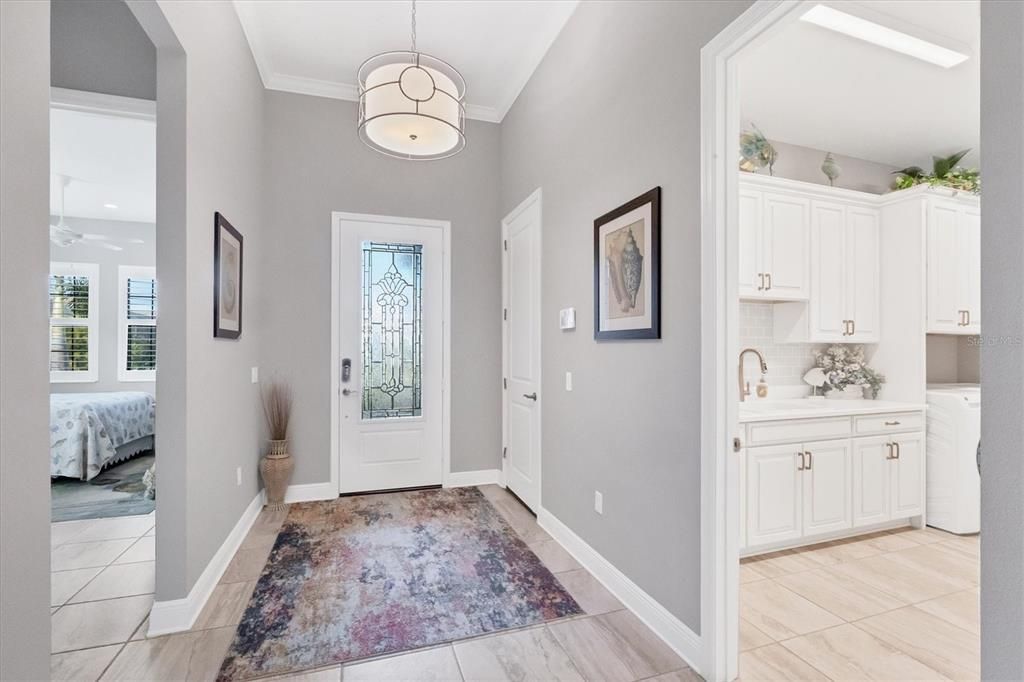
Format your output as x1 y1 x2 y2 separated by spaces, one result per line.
220 487 582 680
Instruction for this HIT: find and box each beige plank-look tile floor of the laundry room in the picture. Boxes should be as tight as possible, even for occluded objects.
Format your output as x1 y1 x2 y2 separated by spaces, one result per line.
739 528 981 682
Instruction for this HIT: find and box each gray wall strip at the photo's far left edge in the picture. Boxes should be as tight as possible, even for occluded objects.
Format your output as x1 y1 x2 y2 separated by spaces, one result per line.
0 0 50 680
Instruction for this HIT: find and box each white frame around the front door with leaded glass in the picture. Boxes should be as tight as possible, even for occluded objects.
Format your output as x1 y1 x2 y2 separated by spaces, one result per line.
331 211 452 496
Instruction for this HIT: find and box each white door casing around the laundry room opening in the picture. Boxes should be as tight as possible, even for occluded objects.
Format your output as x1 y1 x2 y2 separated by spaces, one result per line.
699 0 816 682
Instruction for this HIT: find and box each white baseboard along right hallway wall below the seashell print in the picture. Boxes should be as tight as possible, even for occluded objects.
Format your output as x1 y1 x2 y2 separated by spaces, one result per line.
537 507 705 673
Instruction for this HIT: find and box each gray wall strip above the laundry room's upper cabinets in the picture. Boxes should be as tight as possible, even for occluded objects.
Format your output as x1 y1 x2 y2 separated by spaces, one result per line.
745 140 896 195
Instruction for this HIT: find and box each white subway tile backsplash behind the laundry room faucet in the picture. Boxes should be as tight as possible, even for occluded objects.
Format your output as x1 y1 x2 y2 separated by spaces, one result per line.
739 301 825 385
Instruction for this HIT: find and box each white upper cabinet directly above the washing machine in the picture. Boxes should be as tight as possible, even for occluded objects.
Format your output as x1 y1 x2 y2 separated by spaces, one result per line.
926 198 981 334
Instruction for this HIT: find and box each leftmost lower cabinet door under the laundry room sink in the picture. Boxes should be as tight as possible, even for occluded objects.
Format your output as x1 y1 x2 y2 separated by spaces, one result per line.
746 445 804 548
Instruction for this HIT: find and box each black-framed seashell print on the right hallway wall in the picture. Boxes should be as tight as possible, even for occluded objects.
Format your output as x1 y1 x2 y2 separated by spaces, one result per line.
594 187 662 340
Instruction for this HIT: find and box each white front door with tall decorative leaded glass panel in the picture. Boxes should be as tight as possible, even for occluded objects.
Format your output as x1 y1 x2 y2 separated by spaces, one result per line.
337 216 444 493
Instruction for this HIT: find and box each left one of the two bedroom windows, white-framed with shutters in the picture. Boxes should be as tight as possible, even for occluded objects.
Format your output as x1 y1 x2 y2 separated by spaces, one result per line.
49 263 99 383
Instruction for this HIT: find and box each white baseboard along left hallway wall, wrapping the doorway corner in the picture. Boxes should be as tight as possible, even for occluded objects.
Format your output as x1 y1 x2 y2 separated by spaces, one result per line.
146 491 263 637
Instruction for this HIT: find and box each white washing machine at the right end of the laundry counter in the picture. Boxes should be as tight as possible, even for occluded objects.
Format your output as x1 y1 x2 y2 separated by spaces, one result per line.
926 384 981 535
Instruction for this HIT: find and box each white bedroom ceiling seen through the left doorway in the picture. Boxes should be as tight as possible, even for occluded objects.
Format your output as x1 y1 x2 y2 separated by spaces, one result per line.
50 108 157 222
